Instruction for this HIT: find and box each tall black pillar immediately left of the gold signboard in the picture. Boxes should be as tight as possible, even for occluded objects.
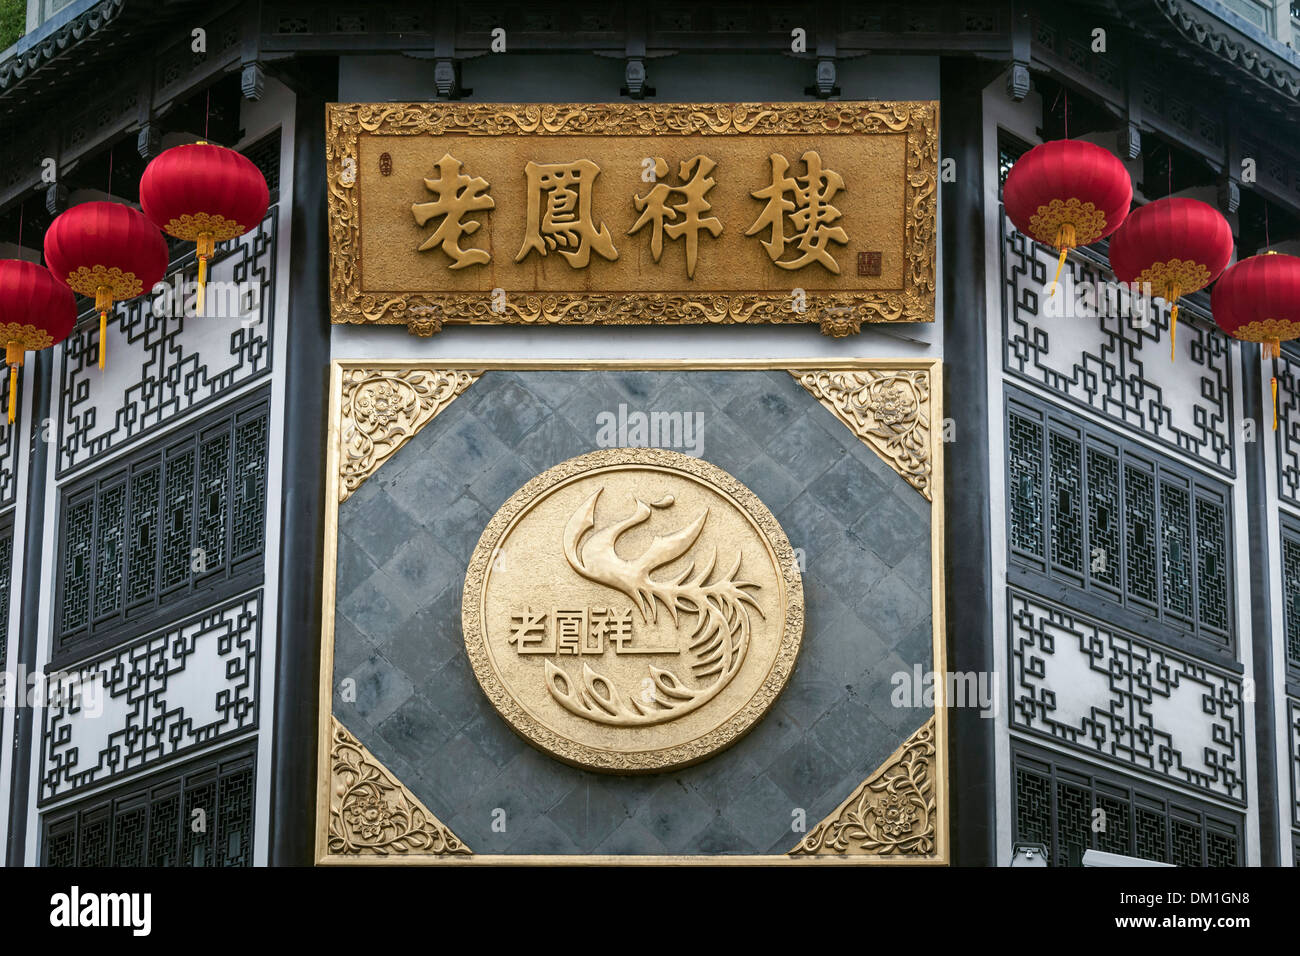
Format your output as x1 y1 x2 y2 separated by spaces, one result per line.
270 57 338 866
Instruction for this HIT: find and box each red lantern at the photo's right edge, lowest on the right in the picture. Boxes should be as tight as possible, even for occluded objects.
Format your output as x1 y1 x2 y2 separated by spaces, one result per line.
1210 252 1300 429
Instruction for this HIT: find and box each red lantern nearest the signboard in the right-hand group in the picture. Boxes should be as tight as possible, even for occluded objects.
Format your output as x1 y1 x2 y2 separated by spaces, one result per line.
1002 139 1134 293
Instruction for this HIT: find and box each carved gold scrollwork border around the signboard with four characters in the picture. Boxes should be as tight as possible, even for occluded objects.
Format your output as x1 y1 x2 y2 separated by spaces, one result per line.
325 100 939 337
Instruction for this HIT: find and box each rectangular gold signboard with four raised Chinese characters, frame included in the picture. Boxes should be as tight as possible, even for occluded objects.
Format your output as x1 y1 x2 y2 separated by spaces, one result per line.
326 101 939 336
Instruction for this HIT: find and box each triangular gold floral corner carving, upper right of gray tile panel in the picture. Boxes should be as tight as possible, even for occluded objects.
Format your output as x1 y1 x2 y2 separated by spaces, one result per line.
790 369 933 501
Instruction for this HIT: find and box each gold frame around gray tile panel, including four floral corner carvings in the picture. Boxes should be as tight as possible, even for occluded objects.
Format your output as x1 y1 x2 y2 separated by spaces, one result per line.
316 359 949 866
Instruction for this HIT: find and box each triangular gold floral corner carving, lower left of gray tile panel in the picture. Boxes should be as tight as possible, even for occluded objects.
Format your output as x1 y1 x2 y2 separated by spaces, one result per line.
328 717 471 856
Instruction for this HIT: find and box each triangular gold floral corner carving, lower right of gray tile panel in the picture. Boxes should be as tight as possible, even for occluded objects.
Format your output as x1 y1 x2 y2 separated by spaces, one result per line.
790 717 937 856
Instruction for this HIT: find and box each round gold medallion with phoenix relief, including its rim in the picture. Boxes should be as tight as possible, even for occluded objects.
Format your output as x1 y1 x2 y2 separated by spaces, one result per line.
462 449 803 773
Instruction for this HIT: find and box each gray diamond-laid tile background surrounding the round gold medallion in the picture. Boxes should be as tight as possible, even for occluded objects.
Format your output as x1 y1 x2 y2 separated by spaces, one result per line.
334 371 932 855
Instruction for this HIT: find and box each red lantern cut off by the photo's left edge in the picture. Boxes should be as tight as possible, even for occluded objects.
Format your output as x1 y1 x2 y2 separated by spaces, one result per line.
0 259 77 424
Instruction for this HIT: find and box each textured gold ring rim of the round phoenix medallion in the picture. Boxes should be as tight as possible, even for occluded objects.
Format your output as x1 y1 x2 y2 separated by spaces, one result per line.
460 449 803 774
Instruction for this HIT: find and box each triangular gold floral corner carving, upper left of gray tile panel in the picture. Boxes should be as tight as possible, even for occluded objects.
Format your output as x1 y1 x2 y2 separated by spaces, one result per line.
338 368 482 503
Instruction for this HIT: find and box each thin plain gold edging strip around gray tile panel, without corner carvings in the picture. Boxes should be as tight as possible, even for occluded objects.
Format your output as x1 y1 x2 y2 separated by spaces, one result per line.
316 358 949 866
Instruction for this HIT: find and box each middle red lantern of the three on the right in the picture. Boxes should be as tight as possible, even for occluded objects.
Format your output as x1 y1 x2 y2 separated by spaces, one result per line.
1110 196 1232 360
